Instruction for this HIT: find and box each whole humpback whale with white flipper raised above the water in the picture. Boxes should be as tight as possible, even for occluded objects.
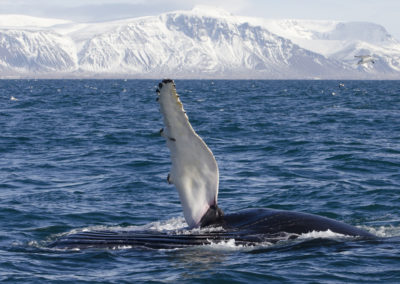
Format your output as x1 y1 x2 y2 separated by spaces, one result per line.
49 79 375 248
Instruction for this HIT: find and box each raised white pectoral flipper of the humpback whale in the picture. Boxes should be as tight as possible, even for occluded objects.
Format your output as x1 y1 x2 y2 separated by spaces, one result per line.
157 79 219 227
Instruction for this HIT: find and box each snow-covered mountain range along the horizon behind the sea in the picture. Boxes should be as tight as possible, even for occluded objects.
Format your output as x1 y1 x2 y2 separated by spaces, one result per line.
0 7 400 79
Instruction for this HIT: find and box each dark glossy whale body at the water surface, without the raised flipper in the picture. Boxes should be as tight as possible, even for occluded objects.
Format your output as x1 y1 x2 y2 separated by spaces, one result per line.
48 208 376 249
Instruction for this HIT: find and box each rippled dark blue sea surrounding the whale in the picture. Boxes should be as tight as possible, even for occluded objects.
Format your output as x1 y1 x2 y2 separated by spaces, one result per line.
0 80 400 283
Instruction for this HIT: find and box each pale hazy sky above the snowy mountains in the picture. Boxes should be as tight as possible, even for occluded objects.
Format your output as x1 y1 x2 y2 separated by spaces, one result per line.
0 0 400 40
